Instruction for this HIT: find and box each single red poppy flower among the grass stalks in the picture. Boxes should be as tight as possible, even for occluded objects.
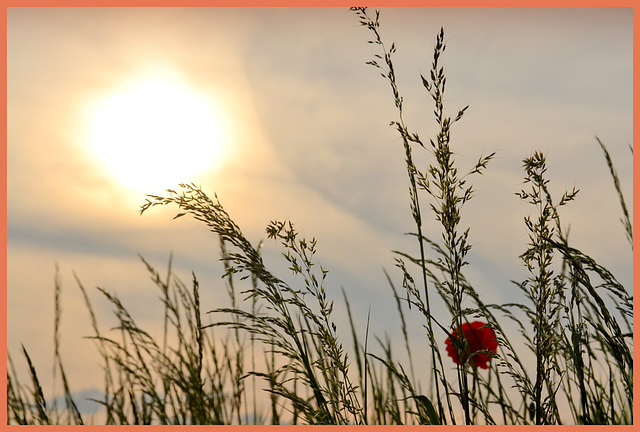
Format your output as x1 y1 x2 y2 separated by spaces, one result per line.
445 321 498 369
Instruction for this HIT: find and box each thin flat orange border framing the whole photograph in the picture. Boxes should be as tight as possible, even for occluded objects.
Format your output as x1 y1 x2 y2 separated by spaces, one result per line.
0 0 640 432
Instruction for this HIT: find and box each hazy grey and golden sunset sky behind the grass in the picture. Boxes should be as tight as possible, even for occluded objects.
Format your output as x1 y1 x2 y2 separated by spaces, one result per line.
7 8 633 416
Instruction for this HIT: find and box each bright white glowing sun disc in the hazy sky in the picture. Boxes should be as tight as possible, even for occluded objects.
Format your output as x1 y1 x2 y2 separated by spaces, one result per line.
90 69 227 192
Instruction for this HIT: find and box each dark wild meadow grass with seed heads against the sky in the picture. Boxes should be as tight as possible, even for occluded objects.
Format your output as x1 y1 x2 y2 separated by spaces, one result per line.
7 8 633 425
